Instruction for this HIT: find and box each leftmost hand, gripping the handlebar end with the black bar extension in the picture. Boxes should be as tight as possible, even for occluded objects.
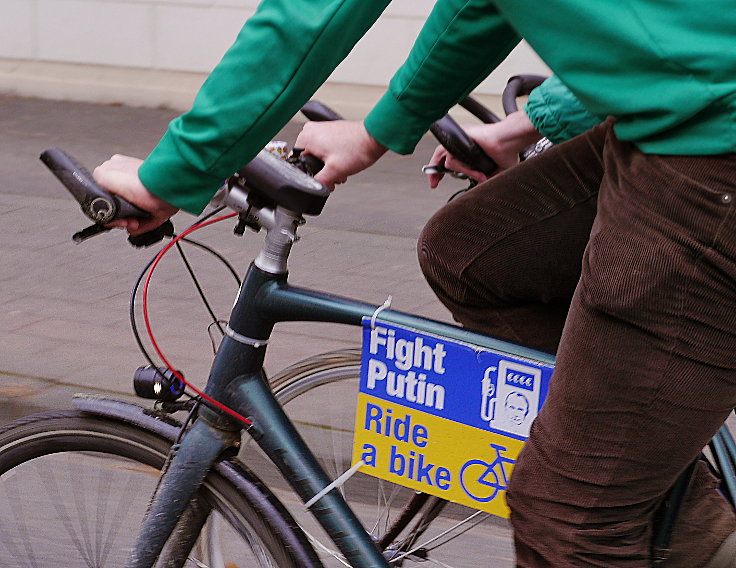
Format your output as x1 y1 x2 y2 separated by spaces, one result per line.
92 154 179 235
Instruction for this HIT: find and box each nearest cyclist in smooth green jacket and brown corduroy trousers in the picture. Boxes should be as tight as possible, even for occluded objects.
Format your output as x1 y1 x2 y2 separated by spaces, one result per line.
96 0 736 568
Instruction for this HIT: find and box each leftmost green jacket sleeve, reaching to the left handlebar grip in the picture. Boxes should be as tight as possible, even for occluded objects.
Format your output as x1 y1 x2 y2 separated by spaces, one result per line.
139 0 391 214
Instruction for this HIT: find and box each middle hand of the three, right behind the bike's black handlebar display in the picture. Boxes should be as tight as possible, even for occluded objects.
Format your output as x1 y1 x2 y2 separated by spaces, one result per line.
295 120 386 191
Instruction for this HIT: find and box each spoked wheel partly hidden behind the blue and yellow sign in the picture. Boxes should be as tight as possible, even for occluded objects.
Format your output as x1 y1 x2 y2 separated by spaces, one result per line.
266 349 513 567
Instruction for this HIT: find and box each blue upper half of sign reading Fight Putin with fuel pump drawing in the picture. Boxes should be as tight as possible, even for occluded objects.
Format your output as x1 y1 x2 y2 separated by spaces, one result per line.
360 320 553 440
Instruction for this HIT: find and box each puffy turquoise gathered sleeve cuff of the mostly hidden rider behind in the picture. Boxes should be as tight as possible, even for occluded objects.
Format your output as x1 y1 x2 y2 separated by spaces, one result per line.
524 75 601 144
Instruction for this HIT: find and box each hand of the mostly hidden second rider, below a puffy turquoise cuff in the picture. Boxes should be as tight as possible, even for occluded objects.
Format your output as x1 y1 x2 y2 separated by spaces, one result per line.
428 110 542 188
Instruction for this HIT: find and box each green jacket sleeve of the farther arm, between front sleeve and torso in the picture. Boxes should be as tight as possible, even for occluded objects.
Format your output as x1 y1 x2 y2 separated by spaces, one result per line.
365 0 520 154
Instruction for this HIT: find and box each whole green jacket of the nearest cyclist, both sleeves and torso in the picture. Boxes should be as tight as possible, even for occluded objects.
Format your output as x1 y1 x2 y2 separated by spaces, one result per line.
140 0 736 212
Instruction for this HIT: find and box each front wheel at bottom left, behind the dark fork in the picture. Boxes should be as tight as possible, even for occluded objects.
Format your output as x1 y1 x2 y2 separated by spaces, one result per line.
0 411 313 568
